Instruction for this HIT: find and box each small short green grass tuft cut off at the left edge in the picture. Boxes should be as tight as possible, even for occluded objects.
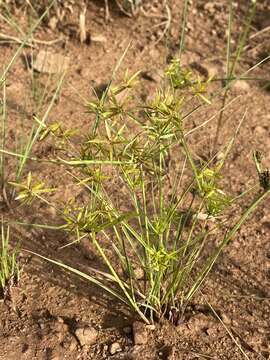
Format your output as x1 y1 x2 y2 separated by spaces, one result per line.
0 221 20 297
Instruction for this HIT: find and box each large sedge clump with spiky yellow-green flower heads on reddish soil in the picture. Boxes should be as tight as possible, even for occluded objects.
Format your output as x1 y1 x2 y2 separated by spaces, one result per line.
8 63 270 323
